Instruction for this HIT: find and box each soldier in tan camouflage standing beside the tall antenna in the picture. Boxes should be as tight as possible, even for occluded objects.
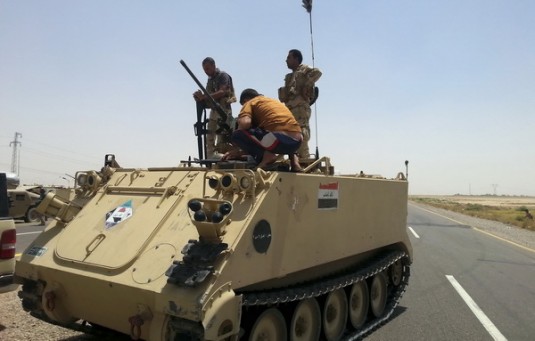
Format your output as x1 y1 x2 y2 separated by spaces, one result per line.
279 50 321 159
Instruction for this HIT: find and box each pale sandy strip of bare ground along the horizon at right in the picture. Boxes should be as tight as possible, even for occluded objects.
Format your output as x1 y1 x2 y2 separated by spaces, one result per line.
410 195 535 210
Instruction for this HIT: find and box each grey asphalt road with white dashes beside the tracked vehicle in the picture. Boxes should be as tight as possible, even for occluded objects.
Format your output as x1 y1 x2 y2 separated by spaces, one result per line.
13 205 535 341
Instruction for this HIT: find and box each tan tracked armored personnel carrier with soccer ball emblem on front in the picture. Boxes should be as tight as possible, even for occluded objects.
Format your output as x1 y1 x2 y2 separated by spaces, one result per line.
15 155 412 340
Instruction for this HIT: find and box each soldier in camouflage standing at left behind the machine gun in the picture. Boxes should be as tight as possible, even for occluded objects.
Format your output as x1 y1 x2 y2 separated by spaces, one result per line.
193 57 236 158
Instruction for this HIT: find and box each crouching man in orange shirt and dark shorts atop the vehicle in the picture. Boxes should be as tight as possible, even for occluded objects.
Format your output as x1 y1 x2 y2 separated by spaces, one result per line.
222 89 303 172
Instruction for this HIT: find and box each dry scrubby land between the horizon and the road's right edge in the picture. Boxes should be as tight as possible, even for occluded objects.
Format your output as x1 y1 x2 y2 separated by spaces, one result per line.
409 195 535 231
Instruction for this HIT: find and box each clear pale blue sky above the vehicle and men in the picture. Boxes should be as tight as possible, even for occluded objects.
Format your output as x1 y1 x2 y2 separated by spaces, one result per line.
0 0 535 196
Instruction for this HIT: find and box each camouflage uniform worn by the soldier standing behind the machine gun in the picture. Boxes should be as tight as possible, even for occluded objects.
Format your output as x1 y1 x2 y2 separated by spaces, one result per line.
206 69 236 158
